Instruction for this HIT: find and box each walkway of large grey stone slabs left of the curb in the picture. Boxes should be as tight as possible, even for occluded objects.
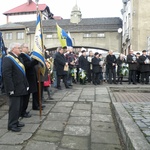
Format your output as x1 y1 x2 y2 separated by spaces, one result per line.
0 85 122 150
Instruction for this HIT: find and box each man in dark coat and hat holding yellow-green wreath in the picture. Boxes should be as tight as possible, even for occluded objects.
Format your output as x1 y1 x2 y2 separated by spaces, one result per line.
79 49 88 84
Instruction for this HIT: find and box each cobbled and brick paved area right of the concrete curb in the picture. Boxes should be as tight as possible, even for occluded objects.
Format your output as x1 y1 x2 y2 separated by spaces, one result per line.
113 86 150 148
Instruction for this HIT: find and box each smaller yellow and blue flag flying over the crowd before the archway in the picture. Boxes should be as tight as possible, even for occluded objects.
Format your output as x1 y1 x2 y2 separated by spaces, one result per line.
56 24 73 47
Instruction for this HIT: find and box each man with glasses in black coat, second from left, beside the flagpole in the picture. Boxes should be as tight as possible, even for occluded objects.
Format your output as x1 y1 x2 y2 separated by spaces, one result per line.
19 43 38 118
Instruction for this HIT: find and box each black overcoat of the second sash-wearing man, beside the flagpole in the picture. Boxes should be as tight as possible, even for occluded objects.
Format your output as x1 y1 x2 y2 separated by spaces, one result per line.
19 53 38 93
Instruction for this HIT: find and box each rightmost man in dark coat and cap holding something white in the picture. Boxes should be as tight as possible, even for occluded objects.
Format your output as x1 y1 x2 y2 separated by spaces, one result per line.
138 50 150 84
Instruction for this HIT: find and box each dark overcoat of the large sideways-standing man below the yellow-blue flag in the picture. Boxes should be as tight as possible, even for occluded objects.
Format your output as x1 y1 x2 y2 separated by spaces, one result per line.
54 52 67 75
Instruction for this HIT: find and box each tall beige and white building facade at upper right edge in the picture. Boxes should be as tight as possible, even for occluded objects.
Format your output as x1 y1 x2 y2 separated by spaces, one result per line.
122 0 150 54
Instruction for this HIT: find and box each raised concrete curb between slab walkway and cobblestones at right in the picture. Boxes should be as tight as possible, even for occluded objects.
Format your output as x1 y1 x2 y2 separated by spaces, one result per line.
108 88 150 150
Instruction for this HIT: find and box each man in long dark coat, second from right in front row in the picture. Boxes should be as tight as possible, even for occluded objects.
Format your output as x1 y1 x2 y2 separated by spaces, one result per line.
127 50 138 84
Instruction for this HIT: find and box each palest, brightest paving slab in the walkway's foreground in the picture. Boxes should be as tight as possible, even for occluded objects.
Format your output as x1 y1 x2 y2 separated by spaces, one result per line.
64 125 90 136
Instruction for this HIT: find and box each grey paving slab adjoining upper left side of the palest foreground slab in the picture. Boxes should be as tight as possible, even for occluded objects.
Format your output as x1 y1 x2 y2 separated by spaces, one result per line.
41 121 65 131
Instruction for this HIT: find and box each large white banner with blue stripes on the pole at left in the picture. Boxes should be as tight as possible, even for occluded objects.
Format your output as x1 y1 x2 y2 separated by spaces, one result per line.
31 12 46 75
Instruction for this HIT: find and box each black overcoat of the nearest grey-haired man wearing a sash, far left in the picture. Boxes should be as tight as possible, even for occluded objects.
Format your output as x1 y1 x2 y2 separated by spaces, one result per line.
2 53 29 96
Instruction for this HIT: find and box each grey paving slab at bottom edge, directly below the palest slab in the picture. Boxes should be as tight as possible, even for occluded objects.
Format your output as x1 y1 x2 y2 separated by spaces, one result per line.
61 136 89 150
